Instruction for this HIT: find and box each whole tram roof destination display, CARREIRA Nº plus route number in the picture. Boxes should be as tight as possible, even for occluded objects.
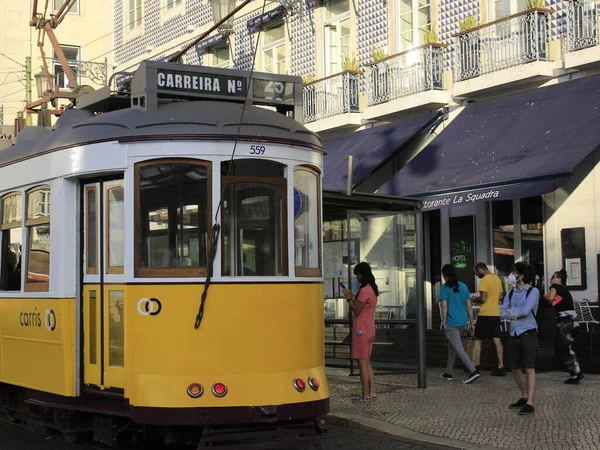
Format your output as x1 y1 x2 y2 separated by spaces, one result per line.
156 68 294 105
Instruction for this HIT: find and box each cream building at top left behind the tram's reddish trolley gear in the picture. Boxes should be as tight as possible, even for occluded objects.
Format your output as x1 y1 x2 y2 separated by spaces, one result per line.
0 0 114 133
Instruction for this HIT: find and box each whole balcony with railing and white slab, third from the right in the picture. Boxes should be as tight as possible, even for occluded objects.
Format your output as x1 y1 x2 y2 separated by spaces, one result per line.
364 44 449 119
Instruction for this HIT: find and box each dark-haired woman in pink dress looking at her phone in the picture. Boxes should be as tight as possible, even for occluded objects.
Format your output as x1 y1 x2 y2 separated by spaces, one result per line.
344 262 379 402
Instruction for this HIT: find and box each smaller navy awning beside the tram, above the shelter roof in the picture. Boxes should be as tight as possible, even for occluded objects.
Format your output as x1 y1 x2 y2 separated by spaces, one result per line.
323 111 441 190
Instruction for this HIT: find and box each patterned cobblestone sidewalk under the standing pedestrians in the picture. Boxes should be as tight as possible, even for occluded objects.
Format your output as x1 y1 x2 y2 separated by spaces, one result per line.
327 368 600 450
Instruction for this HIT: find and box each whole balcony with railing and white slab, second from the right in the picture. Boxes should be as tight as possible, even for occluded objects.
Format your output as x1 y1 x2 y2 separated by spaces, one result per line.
454 8 557 96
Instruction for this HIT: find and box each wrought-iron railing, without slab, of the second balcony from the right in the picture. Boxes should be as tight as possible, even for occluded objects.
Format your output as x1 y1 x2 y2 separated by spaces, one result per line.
454 8 554 81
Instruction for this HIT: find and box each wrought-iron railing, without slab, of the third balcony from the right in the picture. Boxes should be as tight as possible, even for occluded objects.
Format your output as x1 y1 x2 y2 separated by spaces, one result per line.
365 44 445 106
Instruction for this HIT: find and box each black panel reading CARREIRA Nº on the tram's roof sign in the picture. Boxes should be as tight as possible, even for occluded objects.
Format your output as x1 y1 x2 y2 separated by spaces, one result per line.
157 69 246 98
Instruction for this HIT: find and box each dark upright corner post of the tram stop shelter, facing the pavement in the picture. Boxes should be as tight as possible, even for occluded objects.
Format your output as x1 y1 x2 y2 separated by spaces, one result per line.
415 211 427 389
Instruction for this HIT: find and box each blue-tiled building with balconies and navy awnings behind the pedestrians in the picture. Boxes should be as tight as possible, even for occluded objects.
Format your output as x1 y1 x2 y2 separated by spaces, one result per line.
114 0 600 325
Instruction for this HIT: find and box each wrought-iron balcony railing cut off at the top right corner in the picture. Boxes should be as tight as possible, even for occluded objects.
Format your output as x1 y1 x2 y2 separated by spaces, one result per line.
567 0 600 52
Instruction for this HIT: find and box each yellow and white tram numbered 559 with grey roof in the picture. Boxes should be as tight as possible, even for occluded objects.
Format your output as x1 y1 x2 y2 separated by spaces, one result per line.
0 61 329 443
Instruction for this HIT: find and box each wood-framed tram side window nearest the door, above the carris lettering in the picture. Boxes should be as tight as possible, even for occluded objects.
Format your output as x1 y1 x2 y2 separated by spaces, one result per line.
25 186 50 292
